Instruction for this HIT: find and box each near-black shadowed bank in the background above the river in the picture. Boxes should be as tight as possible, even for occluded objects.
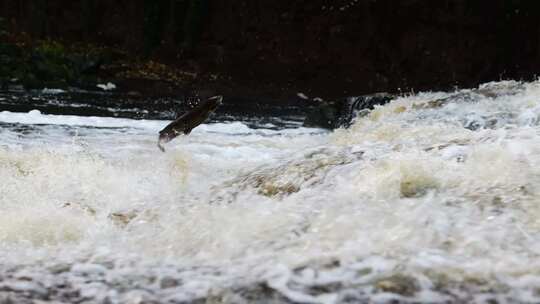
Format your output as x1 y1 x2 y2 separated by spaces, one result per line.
0 0 540 100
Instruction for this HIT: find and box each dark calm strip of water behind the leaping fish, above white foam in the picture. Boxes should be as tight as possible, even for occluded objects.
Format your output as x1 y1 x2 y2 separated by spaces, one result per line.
0 88 313 125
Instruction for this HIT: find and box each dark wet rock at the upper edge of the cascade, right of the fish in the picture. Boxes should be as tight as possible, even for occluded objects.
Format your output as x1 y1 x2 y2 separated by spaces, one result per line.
304 93 395 129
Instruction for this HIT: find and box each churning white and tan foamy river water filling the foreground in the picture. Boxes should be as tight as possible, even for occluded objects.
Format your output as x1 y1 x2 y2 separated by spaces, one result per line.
0 81 540 303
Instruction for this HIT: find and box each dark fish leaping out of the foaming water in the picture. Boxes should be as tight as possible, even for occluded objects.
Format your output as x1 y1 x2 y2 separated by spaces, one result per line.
158 95 223 152
